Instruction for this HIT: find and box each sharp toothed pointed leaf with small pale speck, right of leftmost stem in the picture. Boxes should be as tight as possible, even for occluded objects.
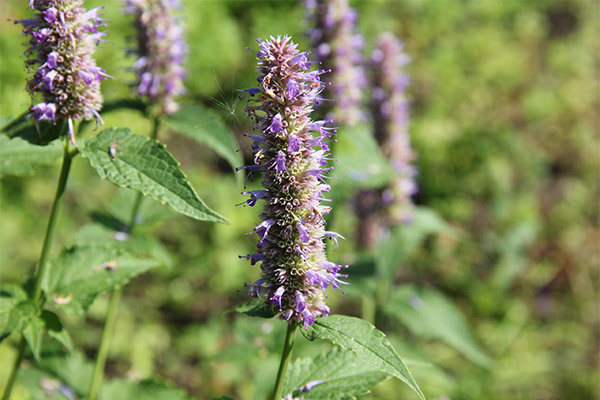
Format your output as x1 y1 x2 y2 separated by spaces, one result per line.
80 128 227 222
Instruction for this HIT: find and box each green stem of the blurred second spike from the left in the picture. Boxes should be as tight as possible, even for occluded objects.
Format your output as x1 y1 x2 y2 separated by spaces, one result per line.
88 118 160 400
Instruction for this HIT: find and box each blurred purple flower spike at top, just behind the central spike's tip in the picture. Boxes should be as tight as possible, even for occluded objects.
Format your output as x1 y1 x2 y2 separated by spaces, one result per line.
305 0 367 125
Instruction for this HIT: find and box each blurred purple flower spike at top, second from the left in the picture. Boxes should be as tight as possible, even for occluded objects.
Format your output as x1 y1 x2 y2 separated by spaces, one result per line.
125 0 187 115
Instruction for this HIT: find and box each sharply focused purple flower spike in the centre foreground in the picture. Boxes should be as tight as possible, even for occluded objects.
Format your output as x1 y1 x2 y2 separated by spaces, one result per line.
242 36 347 326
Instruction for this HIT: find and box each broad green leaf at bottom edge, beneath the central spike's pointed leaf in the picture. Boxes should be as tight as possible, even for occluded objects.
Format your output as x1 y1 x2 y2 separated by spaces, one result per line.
283 347 387 400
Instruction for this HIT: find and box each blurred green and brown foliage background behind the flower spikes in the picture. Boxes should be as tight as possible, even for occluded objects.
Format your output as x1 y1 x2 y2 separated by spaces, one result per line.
0 0 600 400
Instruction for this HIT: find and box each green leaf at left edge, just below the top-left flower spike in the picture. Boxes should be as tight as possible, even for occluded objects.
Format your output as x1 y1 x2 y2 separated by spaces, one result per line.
0 135 63 176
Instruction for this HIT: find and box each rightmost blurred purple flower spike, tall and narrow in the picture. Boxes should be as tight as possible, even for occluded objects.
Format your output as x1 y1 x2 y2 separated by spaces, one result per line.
370 33 417 224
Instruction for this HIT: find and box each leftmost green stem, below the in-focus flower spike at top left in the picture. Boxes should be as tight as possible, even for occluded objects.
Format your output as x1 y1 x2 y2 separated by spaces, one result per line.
2 143 77 400
